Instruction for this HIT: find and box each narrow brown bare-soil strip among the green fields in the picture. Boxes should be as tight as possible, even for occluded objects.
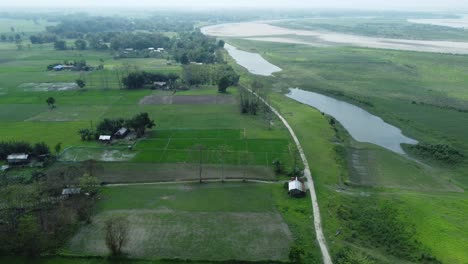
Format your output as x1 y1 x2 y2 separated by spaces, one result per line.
139 95 236 105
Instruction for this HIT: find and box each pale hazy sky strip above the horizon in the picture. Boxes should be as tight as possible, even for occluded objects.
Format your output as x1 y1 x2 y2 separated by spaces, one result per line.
0 0 468 10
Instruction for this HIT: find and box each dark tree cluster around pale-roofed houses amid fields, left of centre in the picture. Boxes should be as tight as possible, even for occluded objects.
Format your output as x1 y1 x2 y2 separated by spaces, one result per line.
78 112 155 140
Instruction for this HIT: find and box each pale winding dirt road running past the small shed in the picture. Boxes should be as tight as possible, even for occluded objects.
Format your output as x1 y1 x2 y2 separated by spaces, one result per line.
249 88 332 264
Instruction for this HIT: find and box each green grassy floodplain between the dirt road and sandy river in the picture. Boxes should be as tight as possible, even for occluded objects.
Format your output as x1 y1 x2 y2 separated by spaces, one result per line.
225 40 468 263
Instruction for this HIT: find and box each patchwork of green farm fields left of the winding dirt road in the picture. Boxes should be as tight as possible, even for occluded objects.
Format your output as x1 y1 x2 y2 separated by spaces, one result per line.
0 21 326 263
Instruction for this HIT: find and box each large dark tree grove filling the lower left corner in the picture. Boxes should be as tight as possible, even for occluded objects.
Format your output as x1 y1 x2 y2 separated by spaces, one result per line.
0 168 99 256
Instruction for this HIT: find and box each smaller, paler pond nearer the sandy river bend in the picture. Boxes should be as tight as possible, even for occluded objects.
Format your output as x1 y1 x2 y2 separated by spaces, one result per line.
224 43 281 76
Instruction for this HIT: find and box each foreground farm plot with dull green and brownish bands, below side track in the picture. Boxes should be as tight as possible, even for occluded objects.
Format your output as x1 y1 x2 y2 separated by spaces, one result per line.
67 183 292 260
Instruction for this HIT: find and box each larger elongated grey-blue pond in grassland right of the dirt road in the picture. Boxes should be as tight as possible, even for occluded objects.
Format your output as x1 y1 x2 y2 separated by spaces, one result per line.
287 88 418 154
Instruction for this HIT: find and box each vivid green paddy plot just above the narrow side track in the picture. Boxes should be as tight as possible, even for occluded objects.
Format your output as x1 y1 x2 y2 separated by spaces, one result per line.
134 129 290 166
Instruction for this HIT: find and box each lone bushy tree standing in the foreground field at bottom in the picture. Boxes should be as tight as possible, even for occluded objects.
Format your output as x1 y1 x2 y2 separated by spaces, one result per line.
105 216 129 256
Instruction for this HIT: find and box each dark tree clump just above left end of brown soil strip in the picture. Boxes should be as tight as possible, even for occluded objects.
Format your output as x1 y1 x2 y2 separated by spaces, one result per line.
122 71 179 89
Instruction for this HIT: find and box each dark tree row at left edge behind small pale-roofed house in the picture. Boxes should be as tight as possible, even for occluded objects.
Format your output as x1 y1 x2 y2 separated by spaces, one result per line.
0 141 50 160
